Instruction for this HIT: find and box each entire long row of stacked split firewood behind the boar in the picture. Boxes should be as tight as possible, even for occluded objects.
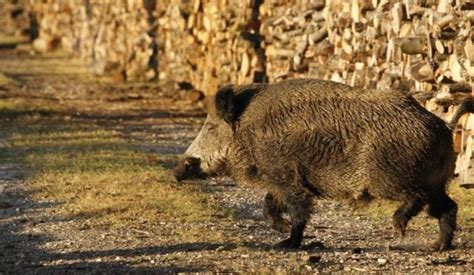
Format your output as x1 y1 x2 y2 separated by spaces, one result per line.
13 0 474 97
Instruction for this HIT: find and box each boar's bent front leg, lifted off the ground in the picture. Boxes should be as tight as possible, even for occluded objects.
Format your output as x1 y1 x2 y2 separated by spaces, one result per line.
263 193 291 233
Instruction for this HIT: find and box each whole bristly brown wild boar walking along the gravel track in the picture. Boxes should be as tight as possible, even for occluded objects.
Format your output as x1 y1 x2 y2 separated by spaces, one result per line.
174 79 470 250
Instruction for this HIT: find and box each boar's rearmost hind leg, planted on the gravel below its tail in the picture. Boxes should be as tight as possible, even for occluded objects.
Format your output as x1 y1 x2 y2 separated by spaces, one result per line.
428 191 458 251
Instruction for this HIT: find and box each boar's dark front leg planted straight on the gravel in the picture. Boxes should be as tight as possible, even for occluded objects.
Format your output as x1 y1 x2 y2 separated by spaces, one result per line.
278 191 312 249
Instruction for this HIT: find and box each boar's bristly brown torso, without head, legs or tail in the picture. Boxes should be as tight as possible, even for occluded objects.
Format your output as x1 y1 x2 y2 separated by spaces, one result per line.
235 79 453 202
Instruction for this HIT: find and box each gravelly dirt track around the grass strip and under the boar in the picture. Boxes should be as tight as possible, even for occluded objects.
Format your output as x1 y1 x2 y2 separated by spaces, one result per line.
0 45 474 273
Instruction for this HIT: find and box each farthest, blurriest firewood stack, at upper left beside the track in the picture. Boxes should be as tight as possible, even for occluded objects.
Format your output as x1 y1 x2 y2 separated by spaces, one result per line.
29 0 157 80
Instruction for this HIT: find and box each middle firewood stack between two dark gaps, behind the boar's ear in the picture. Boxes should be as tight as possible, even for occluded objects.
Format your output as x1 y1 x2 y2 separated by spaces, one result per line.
158 0 264 93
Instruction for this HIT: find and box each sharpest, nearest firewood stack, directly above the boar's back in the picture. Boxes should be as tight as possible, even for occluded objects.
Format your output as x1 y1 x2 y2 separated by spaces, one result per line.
260 0 474 93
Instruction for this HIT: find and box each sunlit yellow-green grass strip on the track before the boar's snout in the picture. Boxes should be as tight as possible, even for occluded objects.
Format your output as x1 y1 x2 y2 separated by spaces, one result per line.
0 101 229 230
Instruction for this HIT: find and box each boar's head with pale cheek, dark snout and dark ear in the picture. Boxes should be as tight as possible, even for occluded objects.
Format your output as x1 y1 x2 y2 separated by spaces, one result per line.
173 85 258 182
